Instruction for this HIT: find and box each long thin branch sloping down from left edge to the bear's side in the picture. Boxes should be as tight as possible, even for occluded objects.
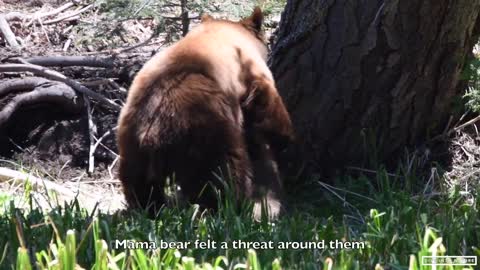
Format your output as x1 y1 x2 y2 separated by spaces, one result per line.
0 64 121 111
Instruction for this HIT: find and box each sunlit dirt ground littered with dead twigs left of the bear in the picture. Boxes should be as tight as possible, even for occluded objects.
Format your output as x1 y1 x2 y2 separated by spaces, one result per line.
0 0 176 212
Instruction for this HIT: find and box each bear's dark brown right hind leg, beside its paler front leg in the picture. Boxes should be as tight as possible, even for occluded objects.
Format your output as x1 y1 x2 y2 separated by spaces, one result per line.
176 121 252 212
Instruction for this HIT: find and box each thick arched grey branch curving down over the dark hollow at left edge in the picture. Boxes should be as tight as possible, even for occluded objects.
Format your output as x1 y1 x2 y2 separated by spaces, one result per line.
0 82 82 127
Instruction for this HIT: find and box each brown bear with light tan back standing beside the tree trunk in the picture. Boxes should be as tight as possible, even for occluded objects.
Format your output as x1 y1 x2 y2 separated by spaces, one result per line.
117 8 293 217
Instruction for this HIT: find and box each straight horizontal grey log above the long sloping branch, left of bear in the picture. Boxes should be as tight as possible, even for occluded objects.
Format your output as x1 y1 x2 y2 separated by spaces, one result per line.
19 56 113 68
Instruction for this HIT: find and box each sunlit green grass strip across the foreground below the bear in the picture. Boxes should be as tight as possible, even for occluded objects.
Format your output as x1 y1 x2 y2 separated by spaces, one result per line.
0 167 480 269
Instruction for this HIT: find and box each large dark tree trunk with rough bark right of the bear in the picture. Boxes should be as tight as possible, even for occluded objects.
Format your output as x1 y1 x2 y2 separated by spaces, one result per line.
270 0 480 173
